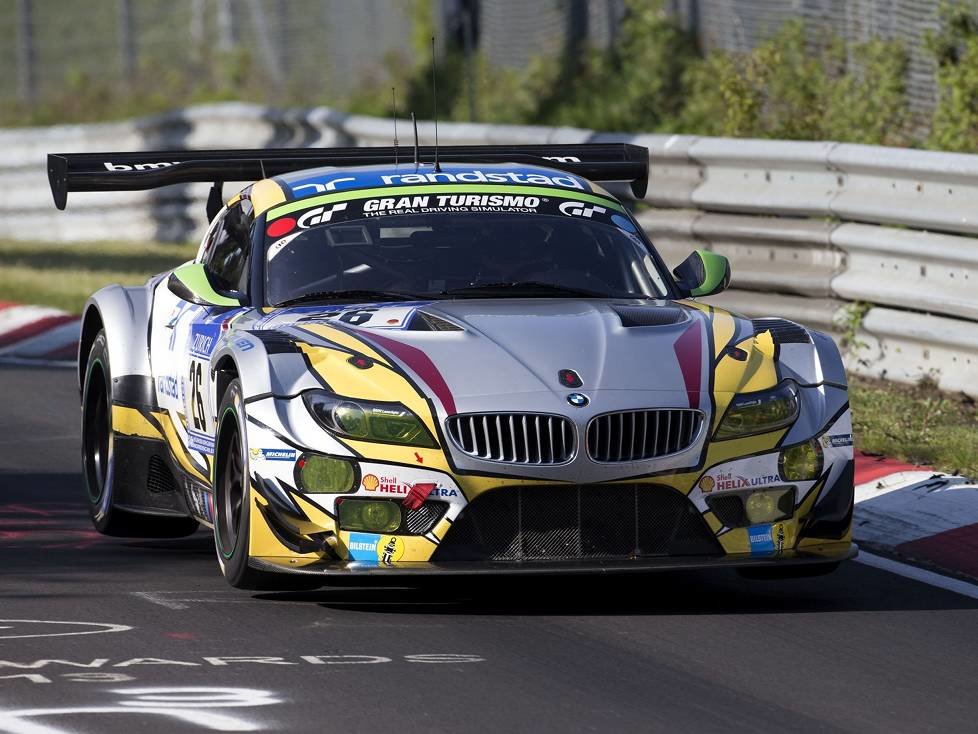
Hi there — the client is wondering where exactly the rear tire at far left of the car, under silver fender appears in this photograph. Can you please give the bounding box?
[81,329,197,538]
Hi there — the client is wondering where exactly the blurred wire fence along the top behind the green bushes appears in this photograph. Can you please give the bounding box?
[0,0,940,131]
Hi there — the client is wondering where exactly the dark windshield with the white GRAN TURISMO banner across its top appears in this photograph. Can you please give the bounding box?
[265,195,668,305]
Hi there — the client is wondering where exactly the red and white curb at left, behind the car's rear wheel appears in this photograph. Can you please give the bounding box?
[0,301,80,365]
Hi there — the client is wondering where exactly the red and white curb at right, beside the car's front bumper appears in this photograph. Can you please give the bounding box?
[853,452,978,579]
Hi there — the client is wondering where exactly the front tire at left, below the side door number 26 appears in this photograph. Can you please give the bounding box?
[214,378,322,591]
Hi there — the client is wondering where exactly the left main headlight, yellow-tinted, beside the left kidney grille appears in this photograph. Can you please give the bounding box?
[302,390,438,448]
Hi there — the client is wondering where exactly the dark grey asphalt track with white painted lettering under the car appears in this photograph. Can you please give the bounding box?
[0,367,978,734]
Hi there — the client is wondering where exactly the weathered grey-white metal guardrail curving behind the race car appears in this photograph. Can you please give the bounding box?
[0,103,978,395]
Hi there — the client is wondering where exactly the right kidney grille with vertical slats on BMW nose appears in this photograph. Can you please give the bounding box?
[587,409,703,463]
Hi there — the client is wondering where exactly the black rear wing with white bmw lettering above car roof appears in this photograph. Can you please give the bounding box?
[48,143,649,209]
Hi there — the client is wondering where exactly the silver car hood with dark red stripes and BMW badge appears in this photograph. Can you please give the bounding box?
[267,299,757,415]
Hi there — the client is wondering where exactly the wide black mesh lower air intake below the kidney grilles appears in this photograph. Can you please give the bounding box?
[432,484,722,562]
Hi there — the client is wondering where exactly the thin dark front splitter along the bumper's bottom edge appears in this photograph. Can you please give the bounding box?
[249,542,859,576]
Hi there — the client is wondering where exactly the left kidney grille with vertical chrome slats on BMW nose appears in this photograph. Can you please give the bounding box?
[446,413,575,464]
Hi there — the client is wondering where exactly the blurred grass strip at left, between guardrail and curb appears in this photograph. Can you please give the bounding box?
[0,240,196,313]
